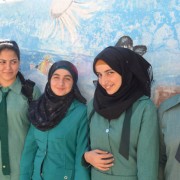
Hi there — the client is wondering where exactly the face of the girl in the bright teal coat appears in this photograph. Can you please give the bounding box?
[50,69,73,96]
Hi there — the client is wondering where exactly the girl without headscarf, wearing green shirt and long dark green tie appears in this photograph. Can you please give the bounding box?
[0,40,40,180]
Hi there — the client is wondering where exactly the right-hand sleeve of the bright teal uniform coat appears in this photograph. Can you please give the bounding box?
[74,108,90,180]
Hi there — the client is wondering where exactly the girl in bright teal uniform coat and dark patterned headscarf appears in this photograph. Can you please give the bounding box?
[20,61,89,180]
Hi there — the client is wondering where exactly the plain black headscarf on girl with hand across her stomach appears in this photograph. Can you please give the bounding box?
[93,46,152,120]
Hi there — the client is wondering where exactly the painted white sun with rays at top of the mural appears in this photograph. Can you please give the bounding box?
[50,0,99,41]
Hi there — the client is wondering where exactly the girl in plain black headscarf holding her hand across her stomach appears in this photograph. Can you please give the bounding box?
[84,47,159,180]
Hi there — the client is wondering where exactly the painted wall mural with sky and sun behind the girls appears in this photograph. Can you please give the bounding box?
[0,0,180,105]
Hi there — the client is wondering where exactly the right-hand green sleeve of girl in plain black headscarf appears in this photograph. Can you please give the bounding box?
[137,101,159,180]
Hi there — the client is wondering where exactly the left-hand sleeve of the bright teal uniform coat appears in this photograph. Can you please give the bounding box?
[20,125,38,180]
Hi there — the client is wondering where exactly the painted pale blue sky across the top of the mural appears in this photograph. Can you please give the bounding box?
[0,0,180,55]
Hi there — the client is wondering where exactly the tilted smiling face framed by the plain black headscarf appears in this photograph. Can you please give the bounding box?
[95,60,122,95]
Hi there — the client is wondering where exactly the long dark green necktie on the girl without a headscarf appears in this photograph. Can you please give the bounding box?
[0,91,10,175]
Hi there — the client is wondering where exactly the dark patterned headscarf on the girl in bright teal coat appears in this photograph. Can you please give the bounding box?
[29,61,86,131]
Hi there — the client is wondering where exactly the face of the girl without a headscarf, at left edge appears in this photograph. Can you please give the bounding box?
[0,49,20,87]
